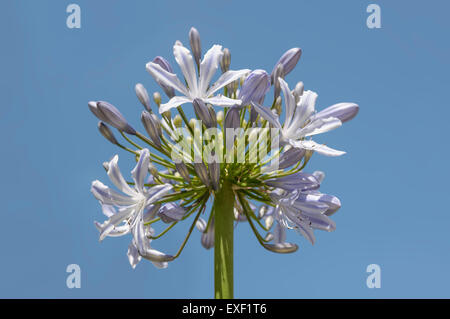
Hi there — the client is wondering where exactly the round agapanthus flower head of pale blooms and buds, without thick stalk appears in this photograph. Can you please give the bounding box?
[88,28,359,268]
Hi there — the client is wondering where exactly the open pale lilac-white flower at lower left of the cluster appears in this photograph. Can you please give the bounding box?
[91,149,172,268]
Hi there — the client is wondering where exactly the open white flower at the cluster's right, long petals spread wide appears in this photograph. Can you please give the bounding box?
[252,78,345,156]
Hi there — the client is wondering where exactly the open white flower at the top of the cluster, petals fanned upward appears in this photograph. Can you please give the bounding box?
[146,44,250,113]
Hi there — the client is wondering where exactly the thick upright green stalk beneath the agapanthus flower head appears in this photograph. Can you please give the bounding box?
[214,181,235,299]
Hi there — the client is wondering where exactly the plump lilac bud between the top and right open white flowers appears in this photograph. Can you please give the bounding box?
[239,70,270,106]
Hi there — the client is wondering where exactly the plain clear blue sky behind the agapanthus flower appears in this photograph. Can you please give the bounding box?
[0,0,450,298]
